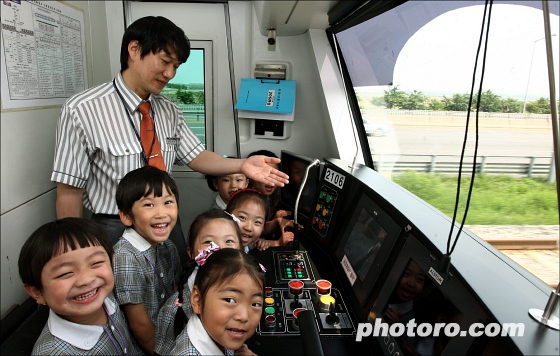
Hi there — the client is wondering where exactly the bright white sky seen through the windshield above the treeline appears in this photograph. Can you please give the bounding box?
[356,4,560,100]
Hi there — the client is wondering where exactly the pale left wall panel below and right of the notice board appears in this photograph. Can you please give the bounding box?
[0,1,115,313]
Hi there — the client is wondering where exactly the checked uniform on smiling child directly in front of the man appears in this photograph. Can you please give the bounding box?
[113,228,181,324]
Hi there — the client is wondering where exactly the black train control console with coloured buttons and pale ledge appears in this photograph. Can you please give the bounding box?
[247,156,558,356]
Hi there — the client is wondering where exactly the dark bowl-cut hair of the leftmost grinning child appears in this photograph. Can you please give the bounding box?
[18,218,113,291]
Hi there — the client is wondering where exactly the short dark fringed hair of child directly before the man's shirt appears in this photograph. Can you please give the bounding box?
[116,166,179,216]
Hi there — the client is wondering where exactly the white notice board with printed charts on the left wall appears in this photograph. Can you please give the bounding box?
[0,0,88,109]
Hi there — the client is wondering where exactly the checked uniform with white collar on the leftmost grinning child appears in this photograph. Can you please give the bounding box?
[31,293,144,355]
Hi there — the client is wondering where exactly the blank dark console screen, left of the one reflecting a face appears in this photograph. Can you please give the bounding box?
[344,208,387,281]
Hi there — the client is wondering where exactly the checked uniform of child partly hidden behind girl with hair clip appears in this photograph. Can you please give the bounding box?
[154,270,196,355]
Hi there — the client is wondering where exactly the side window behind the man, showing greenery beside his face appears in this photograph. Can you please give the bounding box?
[161,41,214,170]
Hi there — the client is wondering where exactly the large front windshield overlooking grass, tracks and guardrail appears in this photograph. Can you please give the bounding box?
[336,1,560,286]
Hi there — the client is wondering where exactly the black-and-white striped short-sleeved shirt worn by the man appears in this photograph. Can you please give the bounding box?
[51,74,204,214]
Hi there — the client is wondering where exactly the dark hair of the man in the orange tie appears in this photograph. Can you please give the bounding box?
[121,16,191,71]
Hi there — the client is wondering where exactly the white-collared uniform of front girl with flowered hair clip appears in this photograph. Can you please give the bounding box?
[171,314,235,356]
